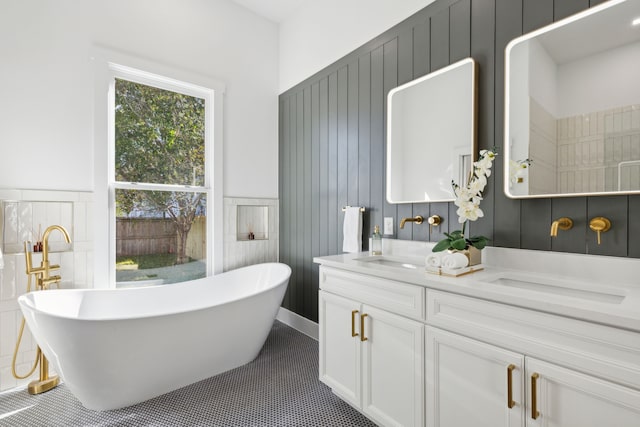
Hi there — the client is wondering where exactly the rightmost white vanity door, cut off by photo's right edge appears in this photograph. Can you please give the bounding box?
[526,358,640,427]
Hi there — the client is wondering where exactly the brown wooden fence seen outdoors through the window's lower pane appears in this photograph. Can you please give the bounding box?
[116,217,206,259]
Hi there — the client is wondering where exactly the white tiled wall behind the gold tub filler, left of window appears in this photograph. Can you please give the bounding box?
[0,190,93,391]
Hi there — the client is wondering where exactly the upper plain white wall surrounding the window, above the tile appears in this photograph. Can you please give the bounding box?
[0,0,278,197]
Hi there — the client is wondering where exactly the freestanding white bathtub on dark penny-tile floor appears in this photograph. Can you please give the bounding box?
[18,263,291,411]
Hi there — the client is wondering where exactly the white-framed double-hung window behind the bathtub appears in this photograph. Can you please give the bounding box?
[109,66,213,287]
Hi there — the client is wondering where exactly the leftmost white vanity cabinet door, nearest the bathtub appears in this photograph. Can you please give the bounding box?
[318,291,362,408]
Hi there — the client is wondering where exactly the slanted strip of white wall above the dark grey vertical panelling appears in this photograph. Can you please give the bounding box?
[280,0,434,93]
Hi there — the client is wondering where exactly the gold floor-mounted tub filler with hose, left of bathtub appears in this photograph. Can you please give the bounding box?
[11,225,71,394]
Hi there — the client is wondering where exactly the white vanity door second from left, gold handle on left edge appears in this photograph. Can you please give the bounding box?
[362,305,424,427]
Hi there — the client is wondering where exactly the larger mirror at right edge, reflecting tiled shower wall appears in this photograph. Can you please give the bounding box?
[504,0,640,198]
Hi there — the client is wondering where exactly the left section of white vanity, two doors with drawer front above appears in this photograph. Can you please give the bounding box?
[319,267,424,426]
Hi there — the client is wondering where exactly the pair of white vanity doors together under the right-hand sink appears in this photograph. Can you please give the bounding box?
[426,327,640,427]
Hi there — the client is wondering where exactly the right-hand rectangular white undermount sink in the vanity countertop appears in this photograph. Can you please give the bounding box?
[482,272,626,304]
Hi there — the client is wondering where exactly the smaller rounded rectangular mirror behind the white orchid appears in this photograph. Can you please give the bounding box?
[387,58,477,203]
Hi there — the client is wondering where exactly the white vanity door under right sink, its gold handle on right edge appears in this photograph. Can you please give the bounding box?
[425,326,524,427]
